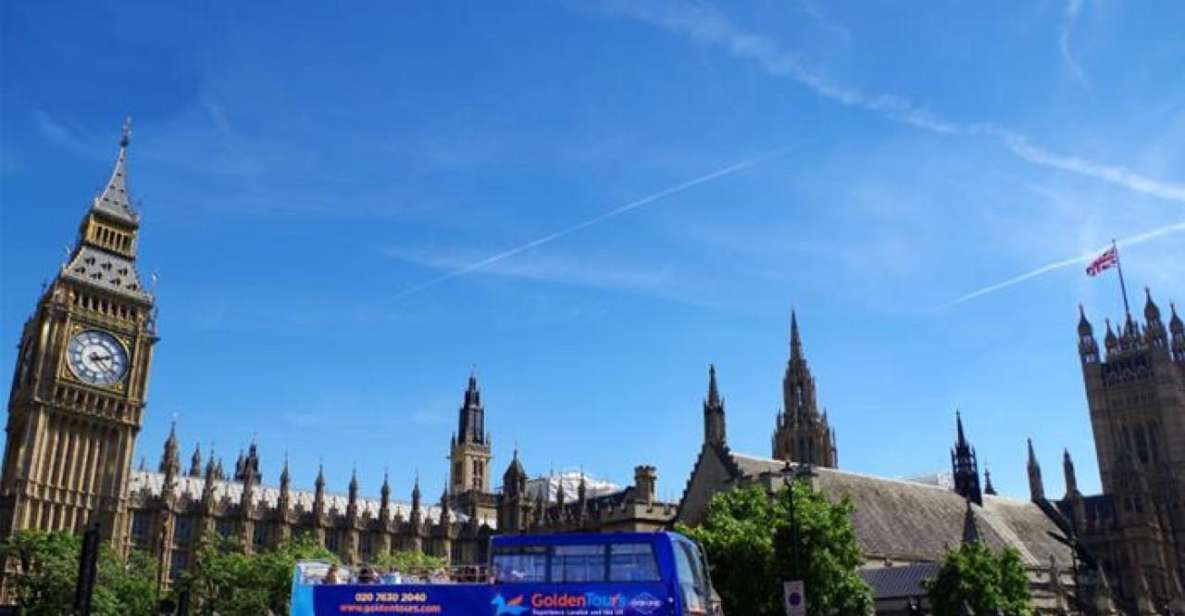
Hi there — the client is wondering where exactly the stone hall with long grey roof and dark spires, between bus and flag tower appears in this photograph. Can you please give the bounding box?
[677,315,1115,614]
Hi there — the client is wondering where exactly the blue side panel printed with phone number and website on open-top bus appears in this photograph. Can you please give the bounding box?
[310,584,495,616]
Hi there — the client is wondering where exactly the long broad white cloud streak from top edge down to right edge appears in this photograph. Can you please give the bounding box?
[610,1,1185,203]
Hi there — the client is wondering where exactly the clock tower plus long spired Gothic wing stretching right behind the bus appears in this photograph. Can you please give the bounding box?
[0,127,674,592]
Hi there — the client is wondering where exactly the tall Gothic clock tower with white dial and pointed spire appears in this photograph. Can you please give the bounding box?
[0,123,156,551]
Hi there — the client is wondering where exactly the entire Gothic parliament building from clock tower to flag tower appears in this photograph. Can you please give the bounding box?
[0,128,1185,615]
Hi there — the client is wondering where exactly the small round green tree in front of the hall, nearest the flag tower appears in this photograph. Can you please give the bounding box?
[925,541,1032,616]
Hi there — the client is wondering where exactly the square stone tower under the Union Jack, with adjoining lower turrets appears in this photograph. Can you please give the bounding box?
[1029,296,1185,614]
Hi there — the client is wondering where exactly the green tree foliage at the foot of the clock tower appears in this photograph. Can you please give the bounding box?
[0,531,156,616]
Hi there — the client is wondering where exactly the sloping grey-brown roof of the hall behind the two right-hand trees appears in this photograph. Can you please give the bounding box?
[730,453,1071,566]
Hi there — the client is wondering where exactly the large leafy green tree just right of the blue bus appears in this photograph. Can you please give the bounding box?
[679,482,872,616]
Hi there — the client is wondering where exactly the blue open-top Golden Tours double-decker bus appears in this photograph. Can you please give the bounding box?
[292,532,722,616]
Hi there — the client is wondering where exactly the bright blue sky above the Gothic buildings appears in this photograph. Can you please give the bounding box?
[0,0,1185,499]
